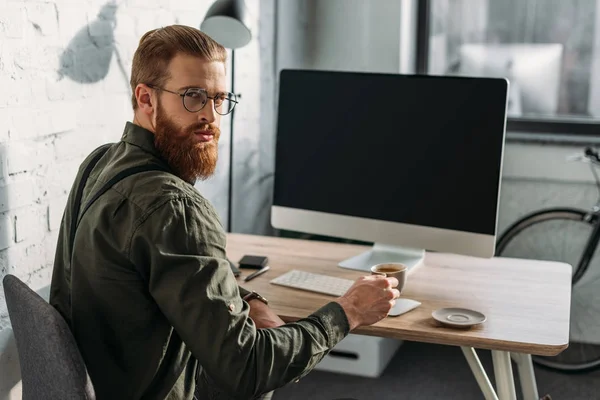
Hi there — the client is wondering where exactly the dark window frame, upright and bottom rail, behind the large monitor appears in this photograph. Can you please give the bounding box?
[415,0,600,143]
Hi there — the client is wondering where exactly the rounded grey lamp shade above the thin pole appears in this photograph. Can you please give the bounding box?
[200,0,252,49]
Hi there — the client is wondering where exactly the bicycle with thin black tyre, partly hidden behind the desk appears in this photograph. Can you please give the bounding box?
[496,147,600,372]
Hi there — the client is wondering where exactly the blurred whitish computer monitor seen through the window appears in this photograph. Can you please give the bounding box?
[459,43,563,117]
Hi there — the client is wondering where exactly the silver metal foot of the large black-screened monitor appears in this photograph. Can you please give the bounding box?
[338,243,425,272]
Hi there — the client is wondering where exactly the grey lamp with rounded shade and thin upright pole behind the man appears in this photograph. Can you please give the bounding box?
[200,0,252,276]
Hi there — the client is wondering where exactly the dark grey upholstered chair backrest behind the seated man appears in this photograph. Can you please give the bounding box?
[3,275,96,400]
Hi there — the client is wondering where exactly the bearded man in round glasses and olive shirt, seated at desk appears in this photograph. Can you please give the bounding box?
[50,25,399,400]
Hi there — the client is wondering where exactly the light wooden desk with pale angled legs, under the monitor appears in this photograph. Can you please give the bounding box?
[227,234,571,400]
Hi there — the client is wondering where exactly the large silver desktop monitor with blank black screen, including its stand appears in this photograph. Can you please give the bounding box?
[271,70,508,271]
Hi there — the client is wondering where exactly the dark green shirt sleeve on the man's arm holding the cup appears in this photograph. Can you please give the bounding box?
[129,198,349,399]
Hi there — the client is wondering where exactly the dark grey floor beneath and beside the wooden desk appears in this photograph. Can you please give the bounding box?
[273,342,600,400]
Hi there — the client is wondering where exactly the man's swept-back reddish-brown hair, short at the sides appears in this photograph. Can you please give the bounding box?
[129,25,227,110]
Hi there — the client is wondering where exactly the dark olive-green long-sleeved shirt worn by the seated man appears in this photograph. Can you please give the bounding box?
[50,122,349,400]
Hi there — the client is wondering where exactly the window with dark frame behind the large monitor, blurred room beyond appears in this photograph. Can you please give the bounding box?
[417,0,600,135]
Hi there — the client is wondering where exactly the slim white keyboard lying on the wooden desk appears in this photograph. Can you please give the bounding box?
[270,269,354,297]
